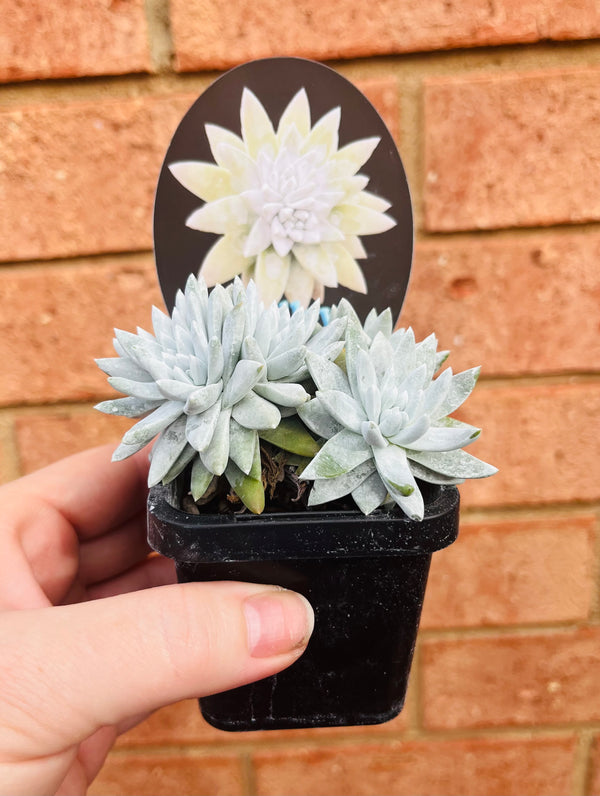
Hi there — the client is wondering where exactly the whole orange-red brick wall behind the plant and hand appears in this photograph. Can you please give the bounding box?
[0,0,600,796]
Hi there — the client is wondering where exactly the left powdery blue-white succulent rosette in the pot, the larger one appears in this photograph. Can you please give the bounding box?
[96,276,346,508]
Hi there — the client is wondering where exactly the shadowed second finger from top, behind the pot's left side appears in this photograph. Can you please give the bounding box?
[78,512,150,584]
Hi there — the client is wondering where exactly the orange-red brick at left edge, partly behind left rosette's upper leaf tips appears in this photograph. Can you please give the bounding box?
[0,256,162,405]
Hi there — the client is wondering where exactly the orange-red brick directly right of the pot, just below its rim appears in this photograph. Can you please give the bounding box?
[421,516,596,628]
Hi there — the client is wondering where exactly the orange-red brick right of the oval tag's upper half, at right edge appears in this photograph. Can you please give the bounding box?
[424,69,600,231]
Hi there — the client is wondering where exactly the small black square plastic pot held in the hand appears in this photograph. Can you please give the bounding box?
[148,486,459,730]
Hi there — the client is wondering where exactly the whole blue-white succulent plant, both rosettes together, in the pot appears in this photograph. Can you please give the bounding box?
[96,276,496,519]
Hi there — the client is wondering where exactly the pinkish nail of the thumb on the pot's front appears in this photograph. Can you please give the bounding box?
[244,589,315,658]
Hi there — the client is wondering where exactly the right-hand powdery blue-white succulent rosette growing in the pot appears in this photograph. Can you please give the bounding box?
[298,318,496,520]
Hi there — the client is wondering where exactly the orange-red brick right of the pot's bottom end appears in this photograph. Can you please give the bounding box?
[421,627,600,729]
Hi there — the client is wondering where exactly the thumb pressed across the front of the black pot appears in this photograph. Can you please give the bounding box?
[0,582,314,759]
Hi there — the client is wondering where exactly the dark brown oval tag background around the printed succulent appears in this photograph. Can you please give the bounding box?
[154,58,413,318]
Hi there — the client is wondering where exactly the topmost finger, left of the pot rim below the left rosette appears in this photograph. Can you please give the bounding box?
[2,445,148,538]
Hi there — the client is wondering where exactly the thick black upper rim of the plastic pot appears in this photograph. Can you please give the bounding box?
[148,486,460,564]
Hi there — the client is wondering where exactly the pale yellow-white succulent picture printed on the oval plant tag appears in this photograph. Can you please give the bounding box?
[169,89,396,307]
